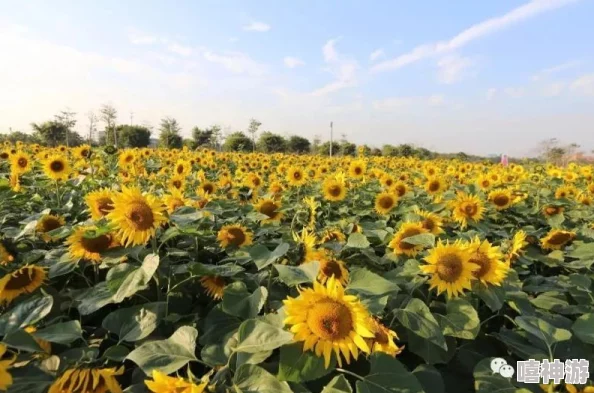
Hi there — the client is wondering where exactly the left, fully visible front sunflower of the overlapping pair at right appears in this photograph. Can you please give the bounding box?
[421,241,479,298]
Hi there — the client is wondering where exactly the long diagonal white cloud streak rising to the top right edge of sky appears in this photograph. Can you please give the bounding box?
[371,0,579,72]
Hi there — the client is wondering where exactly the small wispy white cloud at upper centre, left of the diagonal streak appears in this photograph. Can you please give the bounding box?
[311,39,359,96]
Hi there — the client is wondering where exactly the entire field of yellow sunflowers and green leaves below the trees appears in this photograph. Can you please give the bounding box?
[0,144,594,393]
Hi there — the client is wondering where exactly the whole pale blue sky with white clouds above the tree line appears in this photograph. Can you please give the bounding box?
[0,0,594,156]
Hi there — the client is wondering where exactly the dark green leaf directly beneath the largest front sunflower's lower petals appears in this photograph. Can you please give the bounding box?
[278,343,336,382]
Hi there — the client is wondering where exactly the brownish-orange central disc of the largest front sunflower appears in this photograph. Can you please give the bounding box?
[307,299,353,341]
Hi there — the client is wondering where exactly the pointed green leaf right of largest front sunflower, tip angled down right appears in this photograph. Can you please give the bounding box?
[394,298,447,350]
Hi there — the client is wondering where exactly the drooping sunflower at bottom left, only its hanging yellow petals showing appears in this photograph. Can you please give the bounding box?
[48,367,124,393]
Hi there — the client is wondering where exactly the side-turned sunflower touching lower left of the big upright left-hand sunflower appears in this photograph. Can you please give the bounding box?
[66,226,117,262]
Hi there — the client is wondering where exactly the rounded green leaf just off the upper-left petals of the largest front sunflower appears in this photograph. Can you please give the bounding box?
[222,281,268,319]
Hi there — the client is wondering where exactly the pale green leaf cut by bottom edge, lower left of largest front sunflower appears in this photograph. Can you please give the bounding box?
[233,364,293,393]
